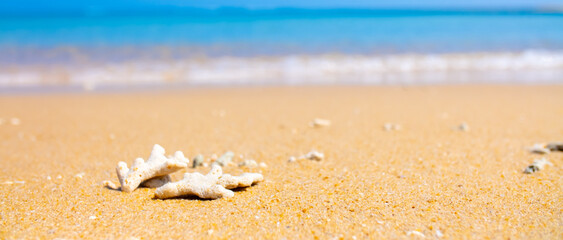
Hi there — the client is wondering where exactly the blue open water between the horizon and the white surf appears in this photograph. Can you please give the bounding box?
[0,10,563,56]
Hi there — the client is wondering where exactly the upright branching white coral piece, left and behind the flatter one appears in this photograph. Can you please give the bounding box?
[116,144,189,192]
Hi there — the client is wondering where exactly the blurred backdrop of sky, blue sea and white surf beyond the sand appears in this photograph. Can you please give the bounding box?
[0,0,563,92]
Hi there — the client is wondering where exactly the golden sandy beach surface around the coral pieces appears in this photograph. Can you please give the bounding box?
[0,86,563,239]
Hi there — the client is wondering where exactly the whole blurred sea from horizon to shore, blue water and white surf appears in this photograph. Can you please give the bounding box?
[0,9,563,86]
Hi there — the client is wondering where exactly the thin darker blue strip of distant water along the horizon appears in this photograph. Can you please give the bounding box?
[0,5,563,17]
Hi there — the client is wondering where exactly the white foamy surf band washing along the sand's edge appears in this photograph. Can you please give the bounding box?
[0,50,563,89]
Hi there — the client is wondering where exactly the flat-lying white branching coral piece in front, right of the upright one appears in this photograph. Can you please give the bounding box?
[155,164,234,199]
